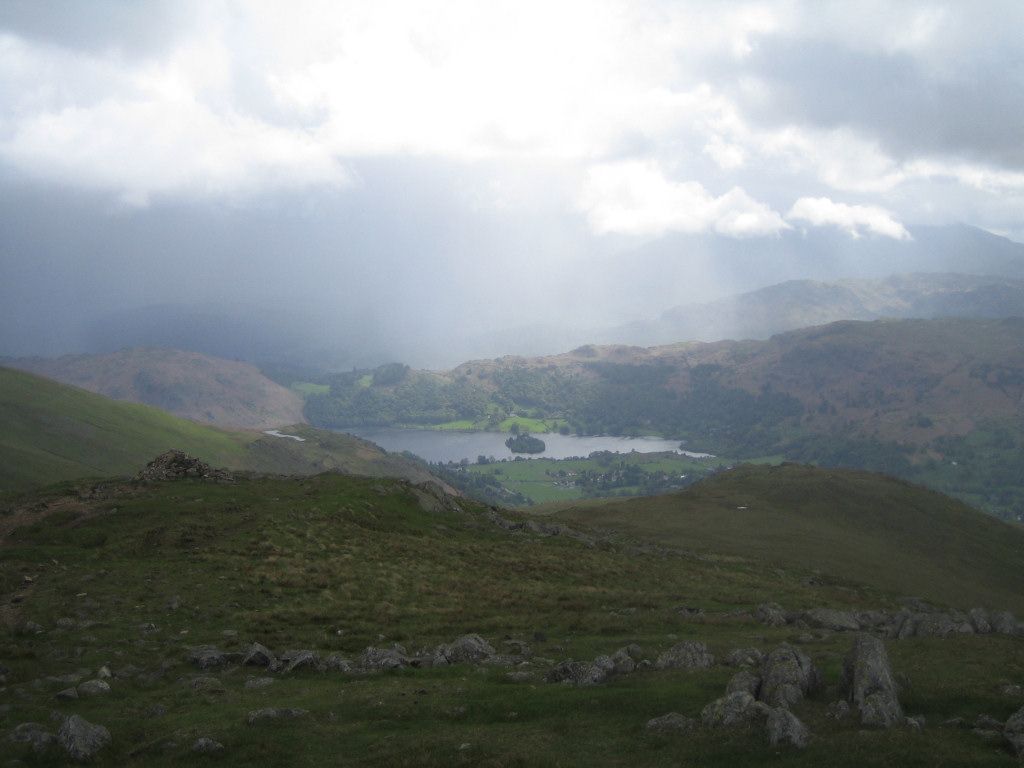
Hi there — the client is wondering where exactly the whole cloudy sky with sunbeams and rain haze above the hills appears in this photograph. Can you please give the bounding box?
[0,0,1024,365]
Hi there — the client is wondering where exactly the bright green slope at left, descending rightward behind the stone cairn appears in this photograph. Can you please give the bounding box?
[0,368,438,497]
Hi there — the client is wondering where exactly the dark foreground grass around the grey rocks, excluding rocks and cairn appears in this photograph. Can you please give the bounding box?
[0,468,1024,768]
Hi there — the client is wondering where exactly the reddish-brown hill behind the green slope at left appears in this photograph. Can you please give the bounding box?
[8,348,304,429]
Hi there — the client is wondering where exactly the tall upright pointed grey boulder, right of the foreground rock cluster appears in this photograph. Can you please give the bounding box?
[843,634,903,728]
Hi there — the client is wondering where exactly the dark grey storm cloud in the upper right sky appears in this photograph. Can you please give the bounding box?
[743,33,1024,168]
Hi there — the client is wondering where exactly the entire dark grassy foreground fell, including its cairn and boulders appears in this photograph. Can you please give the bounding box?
[0,455,1024,766]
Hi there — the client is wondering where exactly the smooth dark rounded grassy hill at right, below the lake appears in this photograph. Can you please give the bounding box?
[555,464,1024,612]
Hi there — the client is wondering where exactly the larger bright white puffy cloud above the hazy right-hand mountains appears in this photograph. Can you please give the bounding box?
[580,161,790,238]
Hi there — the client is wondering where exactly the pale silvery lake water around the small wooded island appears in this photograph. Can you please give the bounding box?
[338,427,711,462]
